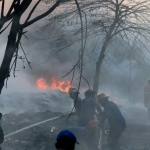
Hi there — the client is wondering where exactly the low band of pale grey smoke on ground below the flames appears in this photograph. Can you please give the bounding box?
[0,91,73,114]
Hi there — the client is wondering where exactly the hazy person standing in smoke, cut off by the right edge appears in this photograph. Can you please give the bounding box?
[144,79,150,121]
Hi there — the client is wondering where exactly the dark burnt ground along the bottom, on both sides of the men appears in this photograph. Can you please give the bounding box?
[2,111,150,150]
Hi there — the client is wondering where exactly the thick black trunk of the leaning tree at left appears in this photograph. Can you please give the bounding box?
[0,0,32,94]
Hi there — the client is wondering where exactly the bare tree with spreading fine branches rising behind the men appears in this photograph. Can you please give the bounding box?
[30,0,150,93]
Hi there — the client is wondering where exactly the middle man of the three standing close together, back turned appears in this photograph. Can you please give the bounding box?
[79,89,96,126]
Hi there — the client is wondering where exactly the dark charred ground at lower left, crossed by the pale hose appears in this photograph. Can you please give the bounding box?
[2,111,69,150]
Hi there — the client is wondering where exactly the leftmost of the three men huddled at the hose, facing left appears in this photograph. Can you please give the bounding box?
[69,87,82,117]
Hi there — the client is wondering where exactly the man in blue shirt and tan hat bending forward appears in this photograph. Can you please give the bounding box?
[97,93,126,150]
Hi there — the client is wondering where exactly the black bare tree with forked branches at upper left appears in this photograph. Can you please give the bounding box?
[0,0,66,93]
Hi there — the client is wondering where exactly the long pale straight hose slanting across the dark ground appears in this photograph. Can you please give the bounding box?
[4,112,70,138]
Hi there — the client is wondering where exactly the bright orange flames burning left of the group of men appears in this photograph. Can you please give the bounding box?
[36,77,71,92]
